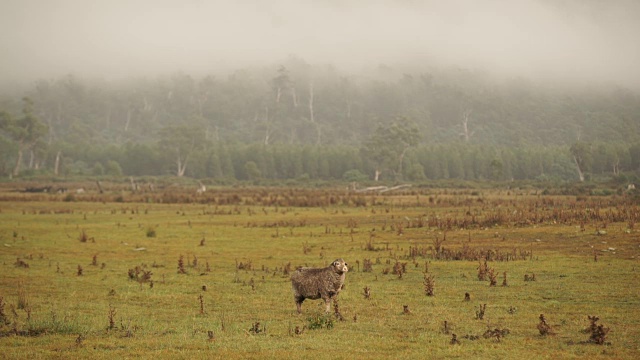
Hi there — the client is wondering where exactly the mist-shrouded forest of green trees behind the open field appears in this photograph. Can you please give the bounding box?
[0,56,640,183]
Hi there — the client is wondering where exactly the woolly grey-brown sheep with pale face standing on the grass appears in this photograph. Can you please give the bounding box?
[291,259,349,314]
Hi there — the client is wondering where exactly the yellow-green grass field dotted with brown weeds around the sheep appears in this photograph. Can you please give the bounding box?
[0,186,640,359]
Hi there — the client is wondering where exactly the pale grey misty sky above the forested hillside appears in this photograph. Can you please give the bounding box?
[0,0,640,88]
